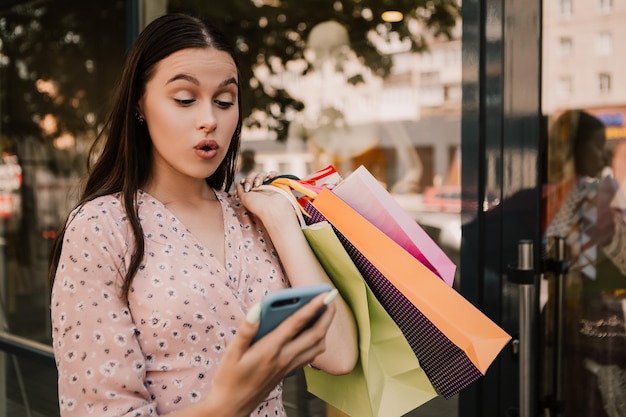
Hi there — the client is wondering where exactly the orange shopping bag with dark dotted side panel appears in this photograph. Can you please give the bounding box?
[307,189,511,398]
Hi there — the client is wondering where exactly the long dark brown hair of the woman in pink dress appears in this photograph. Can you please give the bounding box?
[48,14,241,300]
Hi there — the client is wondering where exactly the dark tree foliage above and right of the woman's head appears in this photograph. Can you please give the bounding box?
[168,0,460,139]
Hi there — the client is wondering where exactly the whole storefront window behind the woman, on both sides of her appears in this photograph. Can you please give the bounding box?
[0,0,462,416]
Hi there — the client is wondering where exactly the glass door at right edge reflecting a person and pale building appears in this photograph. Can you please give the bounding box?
[541,0,626,417]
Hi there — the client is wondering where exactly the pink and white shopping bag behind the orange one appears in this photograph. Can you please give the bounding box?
[333,165,456,286]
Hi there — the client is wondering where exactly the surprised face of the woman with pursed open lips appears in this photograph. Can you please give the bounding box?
[139,48,239,183]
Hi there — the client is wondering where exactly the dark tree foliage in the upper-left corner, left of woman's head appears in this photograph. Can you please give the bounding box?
[0,0,126,172]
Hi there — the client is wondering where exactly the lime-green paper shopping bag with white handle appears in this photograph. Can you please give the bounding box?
[260,181,438,417]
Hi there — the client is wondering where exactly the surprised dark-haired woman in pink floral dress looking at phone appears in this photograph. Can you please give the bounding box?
[50,15,357,417]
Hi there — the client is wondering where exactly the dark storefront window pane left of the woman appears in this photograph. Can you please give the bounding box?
[0,0,127,416]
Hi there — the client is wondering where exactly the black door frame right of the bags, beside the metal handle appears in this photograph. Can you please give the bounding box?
[459,0,544,417]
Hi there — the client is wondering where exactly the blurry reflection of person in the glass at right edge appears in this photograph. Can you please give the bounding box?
[545,111,626,417]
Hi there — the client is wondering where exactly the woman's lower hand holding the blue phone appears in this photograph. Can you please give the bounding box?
[204,293,336,416]
